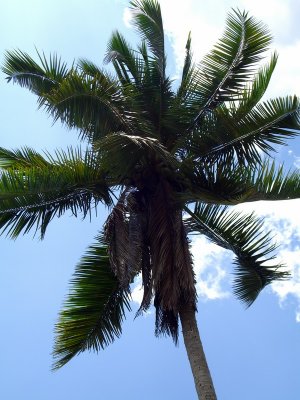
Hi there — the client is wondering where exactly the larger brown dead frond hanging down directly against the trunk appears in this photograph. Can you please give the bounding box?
[147,181,196,342]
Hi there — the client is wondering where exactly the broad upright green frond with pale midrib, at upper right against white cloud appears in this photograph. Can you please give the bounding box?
[193,10,271,126]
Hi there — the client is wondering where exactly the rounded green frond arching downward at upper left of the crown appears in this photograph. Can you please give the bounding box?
[45,72,132,140]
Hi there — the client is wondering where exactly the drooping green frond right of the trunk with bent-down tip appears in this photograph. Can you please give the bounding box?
[185,203,289,306]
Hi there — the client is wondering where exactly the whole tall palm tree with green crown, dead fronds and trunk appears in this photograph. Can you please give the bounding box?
[0,0,300,399]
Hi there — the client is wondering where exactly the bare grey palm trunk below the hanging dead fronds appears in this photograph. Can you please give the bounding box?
[179,305,217,400]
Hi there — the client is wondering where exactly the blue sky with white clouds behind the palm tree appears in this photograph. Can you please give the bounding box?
[0,0,300,400]
